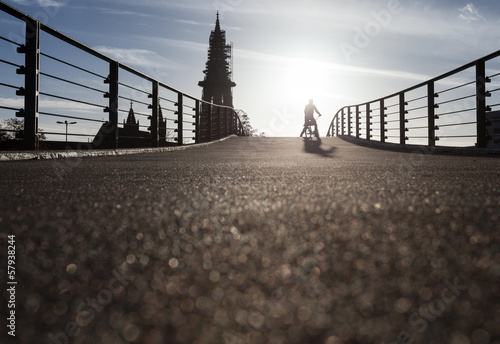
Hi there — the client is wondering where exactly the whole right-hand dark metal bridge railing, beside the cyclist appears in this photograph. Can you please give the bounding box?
[327,50,500,147]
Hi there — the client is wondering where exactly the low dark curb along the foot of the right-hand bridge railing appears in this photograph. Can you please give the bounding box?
[338,135,500,157]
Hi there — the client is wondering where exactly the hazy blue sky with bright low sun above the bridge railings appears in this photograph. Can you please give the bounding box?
[0,0,500,142]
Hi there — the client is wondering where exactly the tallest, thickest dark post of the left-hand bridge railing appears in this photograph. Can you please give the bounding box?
[23,18,40,150]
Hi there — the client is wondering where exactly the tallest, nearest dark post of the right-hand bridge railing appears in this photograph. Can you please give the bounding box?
[476,60,488,148]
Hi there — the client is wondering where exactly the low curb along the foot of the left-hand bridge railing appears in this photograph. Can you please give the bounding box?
[0,135,236,161]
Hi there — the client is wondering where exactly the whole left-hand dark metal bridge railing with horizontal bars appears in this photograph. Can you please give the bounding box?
[0,2,245,150]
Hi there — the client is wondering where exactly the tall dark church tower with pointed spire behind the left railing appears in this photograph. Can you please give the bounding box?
[198,12,236,141]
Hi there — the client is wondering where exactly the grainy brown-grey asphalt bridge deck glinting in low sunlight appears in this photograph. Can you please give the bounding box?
[0,138,500,344]
